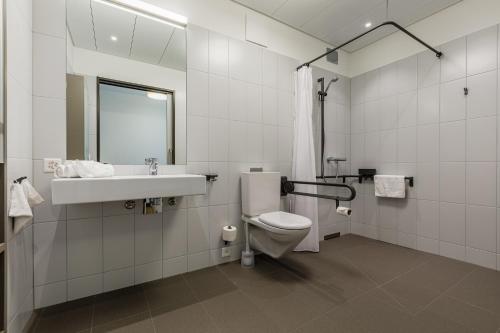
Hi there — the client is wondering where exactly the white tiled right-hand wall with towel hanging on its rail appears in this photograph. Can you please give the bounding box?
[351,26,500,269]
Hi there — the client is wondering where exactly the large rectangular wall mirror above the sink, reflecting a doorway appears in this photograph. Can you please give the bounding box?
[66,0,186,165]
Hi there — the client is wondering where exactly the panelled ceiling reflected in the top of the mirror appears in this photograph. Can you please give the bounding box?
[67,0,186,71]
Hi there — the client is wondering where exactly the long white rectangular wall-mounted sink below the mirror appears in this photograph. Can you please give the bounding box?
[52,174,207,205]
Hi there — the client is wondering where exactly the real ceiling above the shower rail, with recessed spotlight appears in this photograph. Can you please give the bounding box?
[232,0,461,52]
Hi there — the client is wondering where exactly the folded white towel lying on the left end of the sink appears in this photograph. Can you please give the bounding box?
[55,161,115,178]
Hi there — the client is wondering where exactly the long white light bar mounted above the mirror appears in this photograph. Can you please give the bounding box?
[93,0,187,29]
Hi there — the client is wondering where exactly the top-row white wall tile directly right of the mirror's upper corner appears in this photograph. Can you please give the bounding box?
[187,25,208,72]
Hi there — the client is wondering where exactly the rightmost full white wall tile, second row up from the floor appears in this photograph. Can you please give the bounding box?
[467,206,497,252]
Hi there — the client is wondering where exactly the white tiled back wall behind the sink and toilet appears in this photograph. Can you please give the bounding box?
[33,20,349,308]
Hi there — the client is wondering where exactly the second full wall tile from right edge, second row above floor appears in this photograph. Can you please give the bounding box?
[439,202,466,245]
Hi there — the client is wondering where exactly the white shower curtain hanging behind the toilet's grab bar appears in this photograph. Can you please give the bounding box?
[292,66,319,252]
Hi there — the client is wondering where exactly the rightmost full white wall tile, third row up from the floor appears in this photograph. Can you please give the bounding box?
[467,163,497,206]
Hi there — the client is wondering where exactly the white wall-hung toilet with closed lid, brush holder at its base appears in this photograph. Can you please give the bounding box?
[241,172,312,266]
